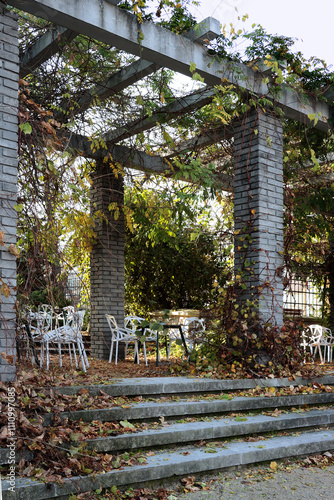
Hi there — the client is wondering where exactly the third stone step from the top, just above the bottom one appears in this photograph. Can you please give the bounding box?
[79,409,334,453]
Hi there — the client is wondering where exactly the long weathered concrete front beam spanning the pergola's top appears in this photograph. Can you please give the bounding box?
[10,0,330,131]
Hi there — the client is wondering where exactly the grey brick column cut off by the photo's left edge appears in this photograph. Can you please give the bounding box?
[0,3,19,381]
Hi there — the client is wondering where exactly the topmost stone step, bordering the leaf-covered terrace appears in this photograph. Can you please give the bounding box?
[55,372,334,397]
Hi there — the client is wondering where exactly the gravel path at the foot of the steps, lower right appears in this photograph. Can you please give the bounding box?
[177,465,334,500]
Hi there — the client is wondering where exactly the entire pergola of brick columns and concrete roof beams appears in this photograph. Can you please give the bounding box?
[0,0,332,380]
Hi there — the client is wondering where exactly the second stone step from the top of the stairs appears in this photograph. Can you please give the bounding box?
[44,392,334,425]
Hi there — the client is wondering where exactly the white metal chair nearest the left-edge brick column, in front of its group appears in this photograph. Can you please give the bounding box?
[43,311,89,372]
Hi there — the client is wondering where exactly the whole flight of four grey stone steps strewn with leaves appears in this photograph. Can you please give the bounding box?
[2,376,334,500]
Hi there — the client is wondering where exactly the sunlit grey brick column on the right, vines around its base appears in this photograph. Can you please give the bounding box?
[234,111,283,326]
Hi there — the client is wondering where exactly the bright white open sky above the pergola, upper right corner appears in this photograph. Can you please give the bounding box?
[191,0,334,71]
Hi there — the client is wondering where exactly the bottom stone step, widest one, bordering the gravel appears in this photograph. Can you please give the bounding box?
[2,430,334,500]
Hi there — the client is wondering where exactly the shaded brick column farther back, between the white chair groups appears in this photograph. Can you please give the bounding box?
[90,161,124,359]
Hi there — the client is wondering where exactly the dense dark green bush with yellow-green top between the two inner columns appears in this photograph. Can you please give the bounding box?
[125,186,229,311]
